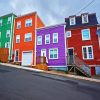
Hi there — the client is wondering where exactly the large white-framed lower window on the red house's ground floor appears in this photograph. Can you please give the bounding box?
[82,46,93,59]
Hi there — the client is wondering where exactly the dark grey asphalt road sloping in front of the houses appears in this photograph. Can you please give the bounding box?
[0,65,100,100]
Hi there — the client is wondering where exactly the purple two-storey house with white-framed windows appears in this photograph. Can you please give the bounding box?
[36,24,67,70]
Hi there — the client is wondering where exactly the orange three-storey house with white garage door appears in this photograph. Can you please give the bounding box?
[13,12,44,66]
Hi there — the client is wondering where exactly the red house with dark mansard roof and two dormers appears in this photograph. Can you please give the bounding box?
[65,13,100,75]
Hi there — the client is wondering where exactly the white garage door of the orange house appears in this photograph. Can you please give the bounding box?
[22,52,32,66]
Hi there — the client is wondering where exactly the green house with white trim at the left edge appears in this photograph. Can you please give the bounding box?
[0,13,16,60]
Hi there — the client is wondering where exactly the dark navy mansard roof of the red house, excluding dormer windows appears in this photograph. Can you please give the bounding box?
[65,13,98,29]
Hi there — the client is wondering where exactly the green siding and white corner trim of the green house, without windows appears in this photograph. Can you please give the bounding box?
[0,14,16,60]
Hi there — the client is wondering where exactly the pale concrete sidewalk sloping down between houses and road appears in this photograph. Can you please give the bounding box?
[0,63,100,83]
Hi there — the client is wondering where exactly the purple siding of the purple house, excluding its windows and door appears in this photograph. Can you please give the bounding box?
[36,25,66,66]
